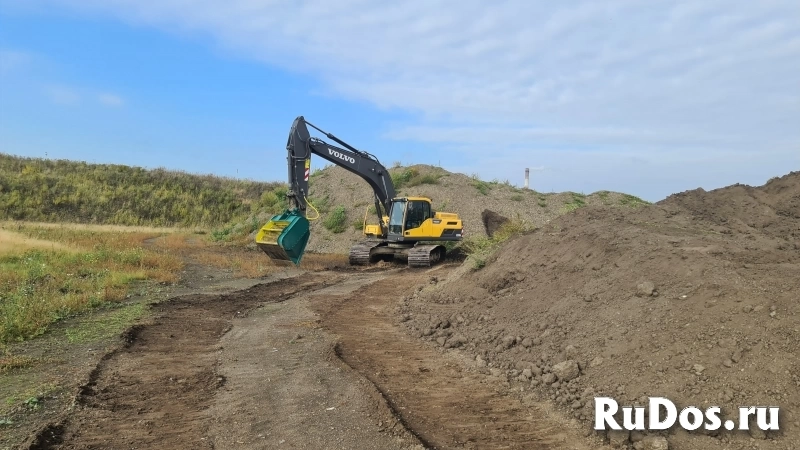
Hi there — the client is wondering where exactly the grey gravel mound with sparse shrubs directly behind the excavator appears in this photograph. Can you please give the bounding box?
[294,163,641,253]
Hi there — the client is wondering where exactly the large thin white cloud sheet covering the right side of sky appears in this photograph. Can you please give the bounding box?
[21,0,800,197]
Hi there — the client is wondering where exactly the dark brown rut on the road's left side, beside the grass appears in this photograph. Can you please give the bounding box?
[27,275,331,449]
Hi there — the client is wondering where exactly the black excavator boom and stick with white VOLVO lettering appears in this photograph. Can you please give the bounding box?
[286,116,395,225]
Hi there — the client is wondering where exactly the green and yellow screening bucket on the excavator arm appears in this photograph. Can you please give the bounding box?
[256,211,311,265]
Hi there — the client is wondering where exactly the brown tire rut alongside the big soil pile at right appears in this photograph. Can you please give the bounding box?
[312,269,590,450]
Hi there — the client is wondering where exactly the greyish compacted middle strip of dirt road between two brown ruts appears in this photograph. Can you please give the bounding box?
[203,273,424,450]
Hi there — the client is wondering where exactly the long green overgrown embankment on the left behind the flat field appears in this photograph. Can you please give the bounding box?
[0,153,285,228]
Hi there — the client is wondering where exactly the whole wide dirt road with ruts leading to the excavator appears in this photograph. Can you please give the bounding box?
[21,266,604,449]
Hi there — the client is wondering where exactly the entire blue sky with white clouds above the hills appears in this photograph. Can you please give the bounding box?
[0,0,800,201]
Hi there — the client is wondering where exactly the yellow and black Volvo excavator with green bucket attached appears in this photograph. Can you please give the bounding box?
[255,116,464,267]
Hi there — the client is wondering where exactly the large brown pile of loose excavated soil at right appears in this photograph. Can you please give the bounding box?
[398,172,800,449]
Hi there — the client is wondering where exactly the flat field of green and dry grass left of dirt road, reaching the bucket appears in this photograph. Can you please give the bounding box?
[0,218,347,344]
